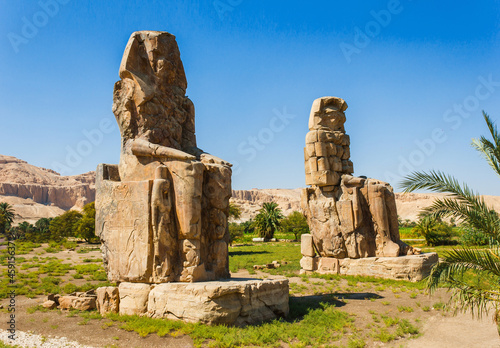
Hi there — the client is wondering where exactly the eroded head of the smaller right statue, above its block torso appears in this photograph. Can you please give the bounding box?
[309,97,347,132]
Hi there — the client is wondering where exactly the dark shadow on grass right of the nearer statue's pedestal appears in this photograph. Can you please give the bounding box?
[288,292,383,321]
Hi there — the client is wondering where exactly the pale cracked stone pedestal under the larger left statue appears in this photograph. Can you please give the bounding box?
[97,279,289,326]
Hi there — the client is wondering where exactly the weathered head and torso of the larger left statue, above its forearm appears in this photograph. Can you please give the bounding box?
[113,31,196,150]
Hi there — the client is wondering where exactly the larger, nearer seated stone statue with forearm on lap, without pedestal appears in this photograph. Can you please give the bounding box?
[96,31,231,283]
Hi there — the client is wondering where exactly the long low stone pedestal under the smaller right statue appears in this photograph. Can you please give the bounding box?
[300,253,438,282]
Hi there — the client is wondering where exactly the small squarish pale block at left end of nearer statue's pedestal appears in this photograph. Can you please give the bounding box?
[118,282,151,315]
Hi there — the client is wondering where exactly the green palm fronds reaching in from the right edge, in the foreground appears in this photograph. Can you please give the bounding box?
[402,112,500,326]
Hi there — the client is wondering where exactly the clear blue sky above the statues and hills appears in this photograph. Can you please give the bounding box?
[0,0,500,195]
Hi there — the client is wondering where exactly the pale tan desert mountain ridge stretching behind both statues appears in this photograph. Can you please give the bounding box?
[0,155,500,223]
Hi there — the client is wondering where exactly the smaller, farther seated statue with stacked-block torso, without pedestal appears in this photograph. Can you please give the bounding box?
[301,97,413,259]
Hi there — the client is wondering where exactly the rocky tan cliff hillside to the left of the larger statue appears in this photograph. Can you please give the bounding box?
[0,155,95,222]
